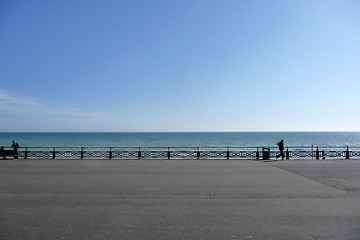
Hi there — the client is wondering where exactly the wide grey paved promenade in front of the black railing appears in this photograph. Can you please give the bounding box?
[0,160,360,240]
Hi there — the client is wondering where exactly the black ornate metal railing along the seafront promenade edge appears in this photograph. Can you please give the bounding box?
[0,146,360,160]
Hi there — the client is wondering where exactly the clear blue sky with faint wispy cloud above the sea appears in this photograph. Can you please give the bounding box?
[0,0,360,132]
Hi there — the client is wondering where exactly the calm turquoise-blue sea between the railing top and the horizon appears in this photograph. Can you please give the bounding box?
[0,132,360,147]
